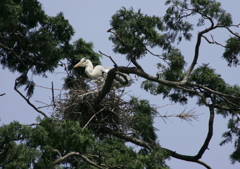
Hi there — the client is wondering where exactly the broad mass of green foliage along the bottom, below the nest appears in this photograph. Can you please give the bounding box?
[0,117,169,169]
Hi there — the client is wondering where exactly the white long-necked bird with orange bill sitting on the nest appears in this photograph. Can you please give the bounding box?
[74,58,133,88]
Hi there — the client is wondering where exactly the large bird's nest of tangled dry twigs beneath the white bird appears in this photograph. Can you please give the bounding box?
[52,81,133,135]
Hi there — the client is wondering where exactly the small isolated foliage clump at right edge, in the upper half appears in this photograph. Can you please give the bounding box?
[223,37,240,66]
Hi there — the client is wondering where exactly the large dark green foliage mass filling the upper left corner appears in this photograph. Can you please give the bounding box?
[0,0,74,97]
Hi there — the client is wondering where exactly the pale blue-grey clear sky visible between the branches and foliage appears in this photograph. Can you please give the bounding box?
[0,0,240,169]
